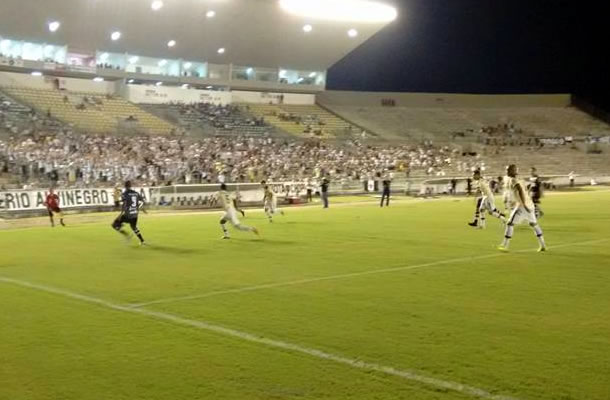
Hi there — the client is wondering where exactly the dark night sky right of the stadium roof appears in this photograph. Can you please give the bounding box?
[328,0,610,106]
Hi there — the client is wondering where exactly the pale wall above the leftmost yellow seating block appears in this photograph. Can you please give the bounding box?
[0,72,116,94]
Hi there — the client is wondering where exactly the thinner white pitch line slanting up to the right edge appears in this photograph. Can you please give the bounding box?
[128,238,610,308]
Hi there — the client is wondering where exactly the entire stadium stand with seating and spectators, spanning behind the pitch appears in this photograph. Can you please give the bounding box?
[0,86,610,191]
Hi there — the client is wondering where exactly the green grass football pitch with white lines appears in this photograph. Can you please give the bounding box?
[0,191,610,400]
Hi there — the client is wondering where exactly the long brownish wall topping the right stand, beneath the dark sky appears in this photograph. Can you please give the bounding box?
[316,90,571,108]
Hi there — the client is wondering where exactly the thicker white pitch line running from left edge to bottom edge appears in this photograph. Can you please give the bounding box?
[0,277,518,400]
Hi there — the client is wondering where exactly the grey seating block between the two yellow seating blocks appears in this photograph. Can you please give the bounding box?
[141,103,274,136]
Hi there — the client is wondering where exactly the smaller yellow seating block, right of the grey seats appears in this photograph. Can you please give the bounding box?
[243,104,361,137]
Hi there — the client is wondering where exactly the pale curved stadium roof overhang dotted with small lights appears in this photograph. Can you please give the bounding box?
[0,0,393,70]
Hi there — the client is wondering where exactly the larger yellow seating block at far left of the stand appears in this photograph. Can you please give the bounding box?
[3,87,175,134]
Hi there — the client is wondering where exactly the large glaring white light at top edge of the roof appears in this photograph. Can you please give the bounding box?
[280,0,398,23]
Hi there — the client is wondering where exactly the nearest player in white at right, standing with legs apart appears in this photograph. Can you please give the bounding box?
[498,164,546,251]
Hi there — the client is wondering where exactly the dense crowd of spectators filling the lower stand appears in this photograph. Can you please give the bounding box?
[0,132,466,186]
